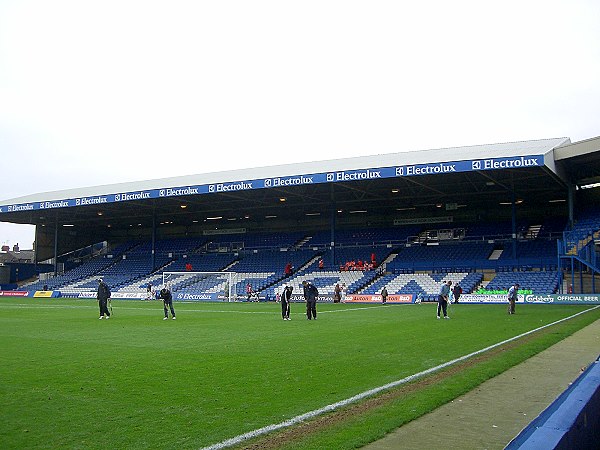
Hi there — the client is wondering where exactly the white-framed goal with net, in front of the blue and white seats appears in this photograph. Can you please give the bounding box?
[162,272,235,302]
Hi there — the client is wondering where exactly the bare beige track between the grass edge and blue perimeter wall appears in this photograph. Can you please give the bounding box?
[363,320,600,450]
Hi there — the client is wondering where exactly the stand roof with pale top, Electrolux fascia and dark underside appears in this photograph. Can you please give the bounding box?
[0,137,600,278]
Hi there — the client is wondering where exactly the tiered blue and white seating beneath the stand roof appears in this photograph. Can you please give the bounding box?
[17,215,576,301]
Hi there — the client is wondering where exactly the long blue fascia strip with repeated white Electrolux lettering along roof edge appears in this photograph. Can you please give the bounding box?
[0,155,544,213]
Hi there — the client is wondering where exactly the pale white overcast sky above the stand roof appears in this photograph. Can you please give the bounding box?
[0,0,600,249]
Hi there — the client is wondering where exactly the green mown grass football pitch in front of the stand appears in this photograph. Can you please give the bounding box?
[0,298,600,449]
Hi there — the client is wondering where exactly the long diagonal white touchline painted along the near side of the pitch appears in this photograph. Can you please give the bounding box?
[201,305,600,450]
